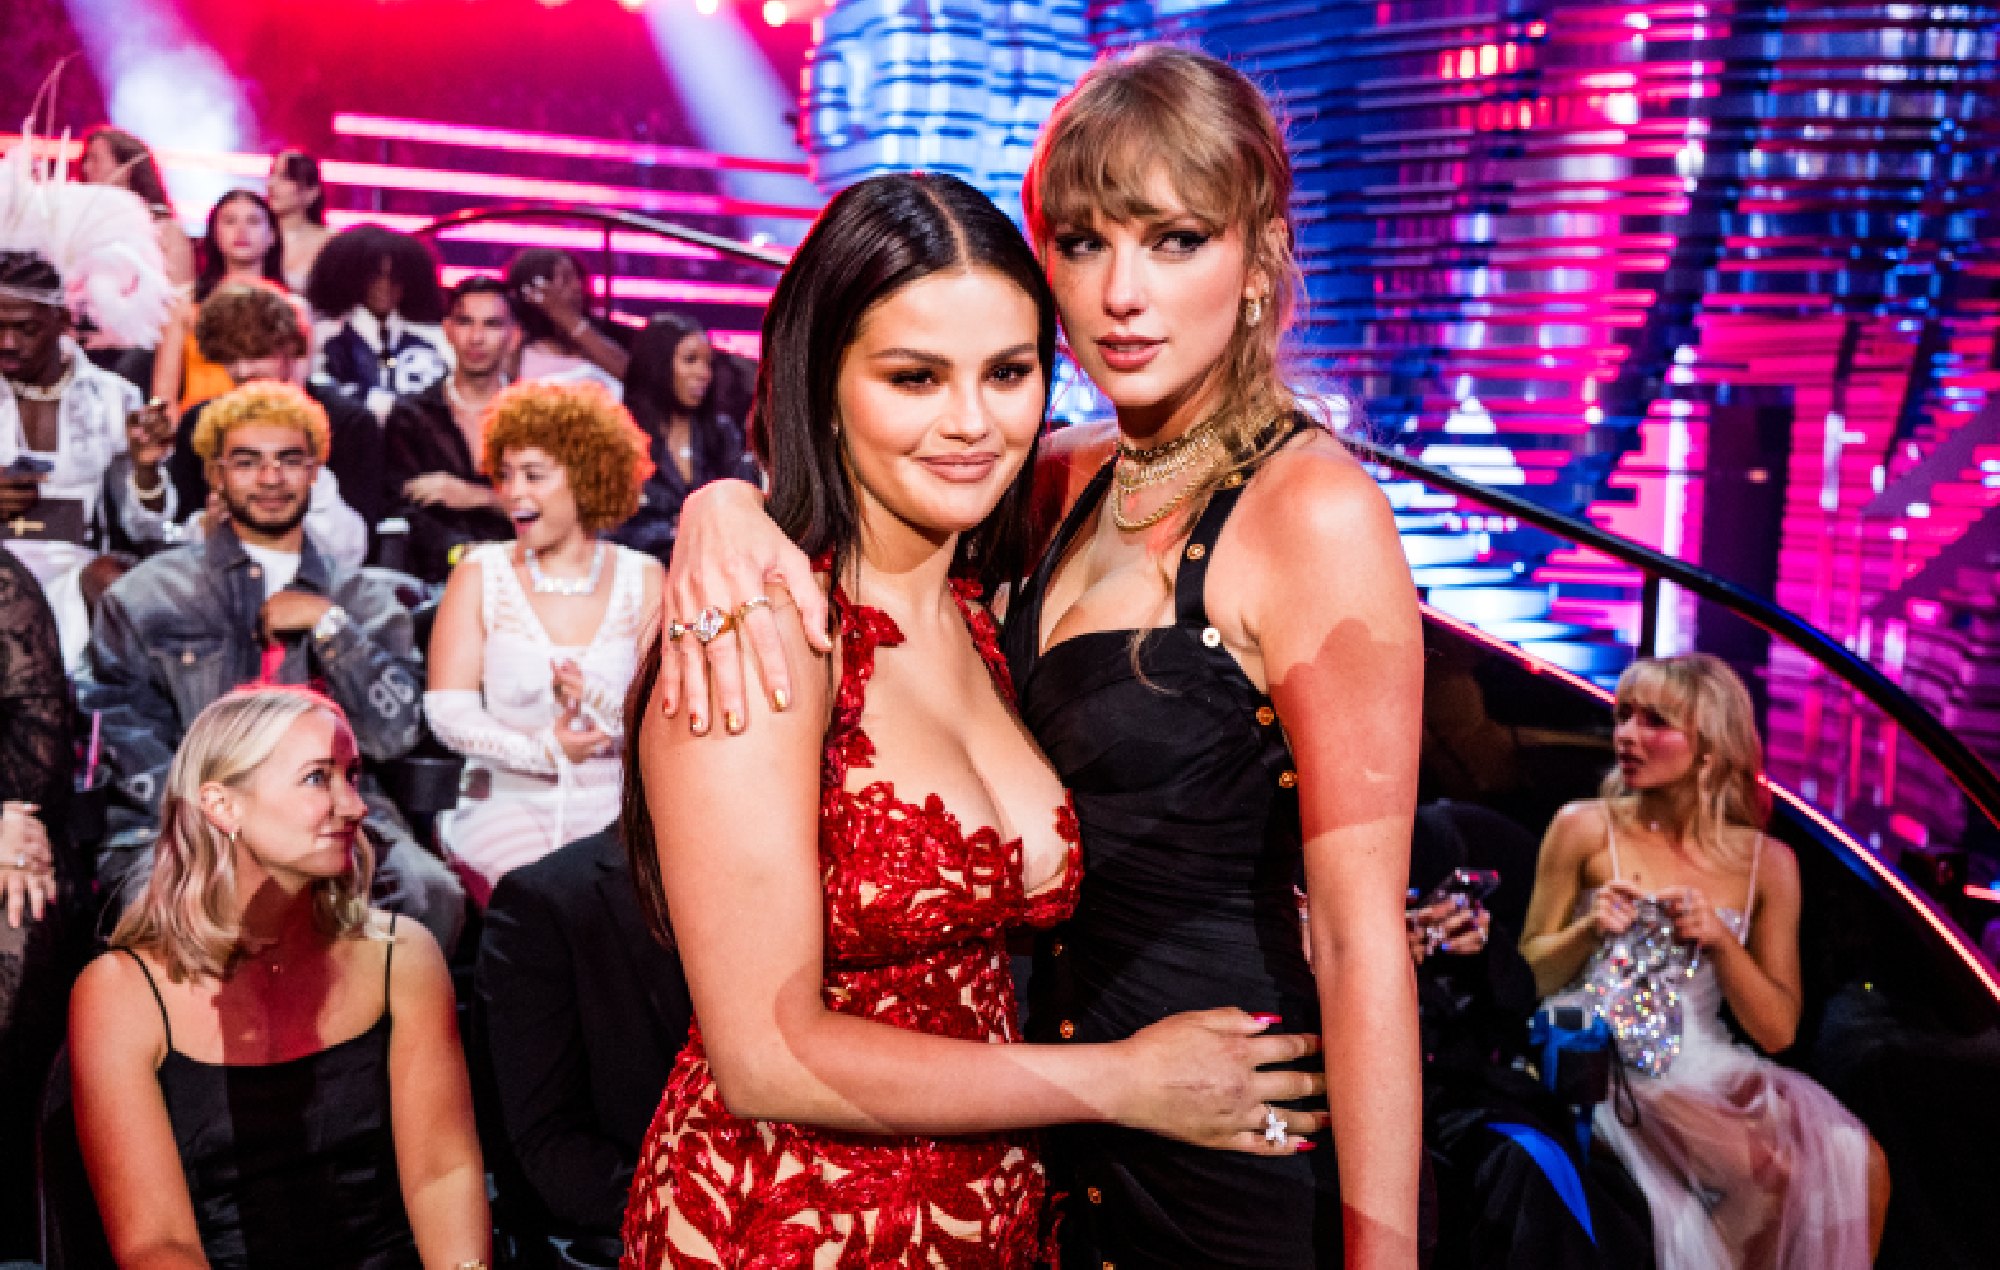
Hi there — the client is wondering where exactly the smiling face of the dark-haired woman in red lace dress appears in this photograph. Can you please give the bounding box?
[836,268,1044,540]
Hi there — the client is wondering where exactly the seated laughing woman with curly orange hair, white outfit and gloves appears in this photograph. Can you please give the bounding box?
[424,384,660,902]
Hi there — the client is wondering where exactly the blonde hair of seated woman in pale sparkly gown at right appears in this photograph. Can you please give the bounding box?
[1598,652,1770,868]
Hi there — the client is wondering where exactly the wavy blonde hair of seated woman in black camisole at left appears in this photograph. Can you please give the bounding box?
[110,686,374,982]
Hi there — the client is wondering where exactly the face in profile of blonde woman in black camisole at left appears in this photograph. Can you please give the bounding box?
[219,710,368,890]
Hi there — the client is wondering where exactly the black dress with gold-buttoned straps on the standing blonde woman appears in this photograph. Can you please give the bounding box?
[1004,440,1342,1270]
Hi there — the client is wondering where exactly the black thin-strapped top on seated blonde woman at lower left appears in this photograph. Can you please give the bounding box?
[122,926,422,1270]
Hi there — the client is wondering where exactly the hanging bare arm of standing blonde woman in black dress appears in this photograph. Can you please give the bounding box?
[1242,448,1424,1268]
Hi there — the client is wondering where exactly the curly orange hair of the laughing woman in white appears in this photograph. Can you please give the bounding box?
[480,382,652,534]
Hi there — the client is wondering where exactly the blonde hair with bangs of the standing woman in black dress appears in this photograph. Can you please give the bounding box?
[1020,44,1304,516]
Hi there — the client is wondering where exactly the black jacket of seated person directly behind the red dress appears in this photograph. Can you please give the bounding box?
[476,826,692,1234]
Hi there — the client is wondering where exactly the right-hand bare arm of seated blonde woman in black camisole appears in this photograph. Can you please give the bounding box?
[388,922,492,1268]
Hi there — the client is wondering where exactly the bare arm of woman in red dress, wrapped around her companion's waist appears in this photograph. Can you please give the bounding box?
[638,604,1320,1154]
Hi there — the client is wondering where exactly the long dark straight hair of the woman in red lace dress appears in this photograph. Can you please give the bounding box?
[622,172,1056,944]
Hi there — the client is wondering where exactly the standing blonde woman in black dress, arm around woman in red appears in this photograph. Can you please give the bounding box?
[648,48,1422,1268]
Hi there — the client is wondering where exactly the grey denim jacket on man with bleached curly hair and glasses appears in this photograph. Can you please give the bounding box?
[78,526,424,892]
